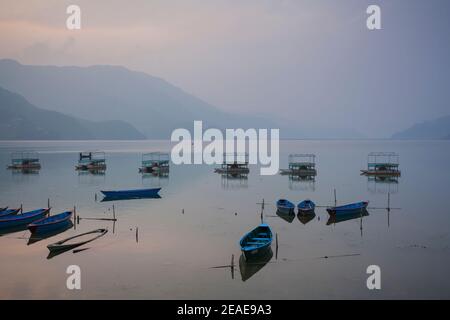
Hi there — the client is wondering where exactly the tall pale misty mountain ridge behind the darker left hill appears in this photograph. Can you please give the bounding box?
[0,59,363,139]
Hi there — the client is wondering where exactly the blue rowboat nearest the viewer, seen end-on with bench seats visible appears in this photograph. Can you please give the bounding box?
[239,223,273,259]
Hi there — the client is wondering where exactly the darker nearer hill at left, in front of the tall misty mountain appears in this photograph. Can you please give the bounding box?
[0,87,145,140]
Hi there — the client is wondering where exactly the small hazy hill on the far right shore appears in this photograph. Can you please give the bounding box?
[392,116,450,140]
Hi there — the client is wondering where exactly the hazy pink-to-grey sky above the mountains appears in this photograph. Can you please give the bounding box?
[0,0,450,137]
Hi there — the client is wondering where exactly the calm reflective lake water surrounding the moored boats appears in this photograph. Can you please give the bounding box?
[0,141,450,299]
